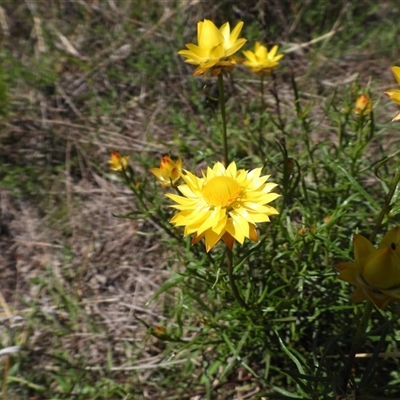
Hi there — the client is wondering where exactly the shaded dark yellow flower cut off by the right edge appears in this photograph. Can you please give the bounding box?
[336,227,400,308]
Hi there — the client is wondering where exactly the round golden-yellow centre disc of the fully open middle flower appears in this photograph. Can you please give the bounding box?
[202,176,240,207]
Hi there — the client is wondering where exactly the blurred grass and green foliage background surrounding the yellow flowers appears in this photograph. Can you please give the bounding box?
[0,0,400,400]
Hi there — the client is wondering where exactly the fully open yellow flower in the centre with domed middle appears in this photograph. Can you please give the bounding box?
[166,162,279,252]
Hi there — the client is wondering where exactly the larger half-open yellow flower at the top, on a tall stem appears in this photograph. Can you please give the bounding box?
[178,19,246,76]
